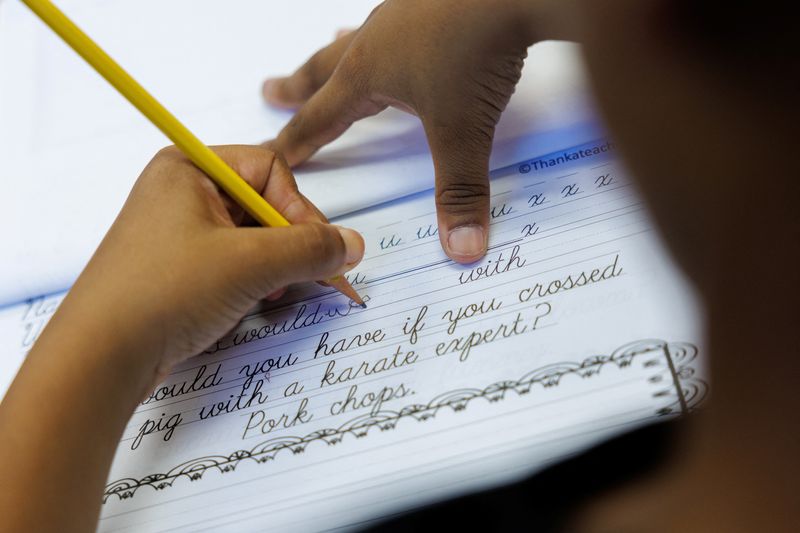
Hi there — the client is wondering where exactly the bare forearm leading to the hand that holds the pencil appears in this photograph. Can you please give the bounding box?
[0,286,159,530]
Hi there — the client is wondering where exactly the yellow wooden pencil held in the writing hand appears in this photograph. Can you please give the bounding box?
[22,0,366,307]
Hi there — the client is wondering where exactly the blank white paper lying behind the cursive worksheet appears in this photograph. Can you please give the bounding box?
[0,0,598,305]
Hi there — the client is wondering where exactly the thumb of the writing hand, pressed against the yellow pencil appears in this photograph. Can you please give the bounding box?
[222,223,364,300]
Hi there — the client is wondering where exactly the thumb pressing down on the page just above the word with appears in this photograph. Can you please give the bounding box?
[423,117,494,263]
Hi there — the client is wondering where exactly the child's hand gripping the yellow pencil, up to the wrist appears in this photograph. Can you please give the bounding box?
[57,146,364,385]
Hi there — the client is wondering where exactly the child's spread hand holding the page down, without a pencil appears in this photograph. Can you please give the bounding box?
[264,0,564,263]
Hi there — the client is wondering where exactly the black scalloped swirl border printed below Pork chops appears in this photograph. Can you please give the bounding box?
[103,339,708,503]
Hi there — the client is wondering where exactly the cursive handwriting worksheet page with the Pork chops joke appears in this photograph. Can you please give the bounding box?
[0,140,706,531]
